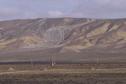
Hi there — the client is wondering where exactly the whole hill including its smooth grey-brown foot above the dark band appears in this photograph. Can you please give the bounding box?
[0,18,126,62]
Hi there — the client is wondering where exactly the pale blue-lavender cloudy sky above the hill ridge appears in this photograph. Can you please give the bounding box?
[0,0,126,20]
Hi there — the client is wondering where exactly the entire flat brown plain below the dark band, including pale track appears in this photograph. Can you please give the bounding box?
[0,64,126,84]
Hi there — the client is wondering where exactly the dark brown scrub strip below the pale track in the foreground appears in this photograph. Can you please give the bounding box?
[0,73,126,84]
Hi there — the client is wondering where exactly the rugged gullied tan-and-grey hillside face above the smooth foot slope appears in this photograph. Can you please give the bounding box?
[0,18,126,52]
